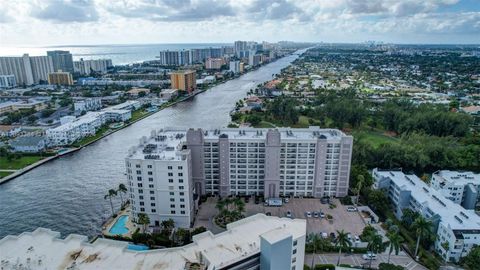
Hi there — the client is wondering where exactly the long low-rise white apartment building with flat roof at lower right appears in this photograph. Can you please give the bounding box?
[373,169,480,262]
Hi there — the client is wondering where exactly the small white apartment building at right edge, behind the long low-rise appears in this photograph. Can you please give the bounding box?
[430,170,480,209]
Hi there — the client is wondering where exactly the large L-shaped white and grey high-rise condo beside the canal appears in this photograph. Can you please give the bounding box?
[126,127,353,227]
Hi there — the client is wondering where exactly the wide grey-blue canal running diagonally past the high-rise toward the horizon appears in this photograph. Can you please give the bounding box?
[0,49,299,239]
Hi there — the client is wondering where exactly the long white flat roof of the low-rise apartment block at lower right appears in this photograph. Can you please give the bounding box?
[374,169,480,230]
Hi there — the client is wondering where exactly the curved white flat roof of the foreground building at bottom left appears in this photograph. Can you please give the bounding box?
[0,214,306,270]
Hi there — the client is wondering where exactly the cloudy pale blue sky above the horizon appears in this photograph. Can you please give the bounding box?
[0,0,480,47]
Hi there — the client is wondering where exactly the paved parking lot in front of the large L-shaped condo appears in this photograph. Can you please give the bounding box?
[195,198,365,237]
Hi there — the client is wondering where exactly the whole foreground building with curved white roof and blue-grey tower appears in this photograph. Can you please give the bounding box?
[0,214,306,270]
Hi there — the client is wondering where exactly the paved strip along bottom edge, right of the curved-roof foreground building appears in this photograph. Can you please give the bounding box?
[305,252,427,270]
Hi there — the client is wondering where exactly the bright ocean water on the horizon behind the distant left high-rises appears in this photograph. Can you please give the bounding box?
[0,43,232,65]
